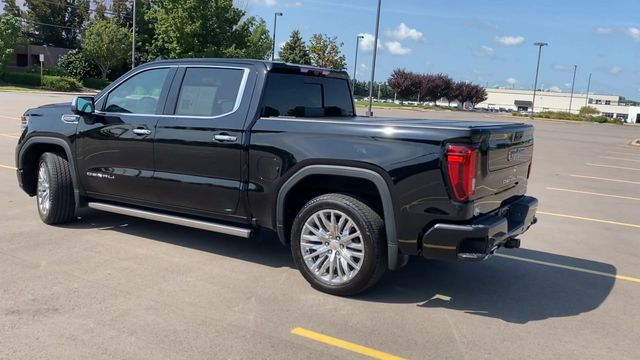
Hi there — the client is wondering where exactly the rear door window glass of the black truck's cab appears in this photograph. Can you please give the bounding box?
[175,68,244,116]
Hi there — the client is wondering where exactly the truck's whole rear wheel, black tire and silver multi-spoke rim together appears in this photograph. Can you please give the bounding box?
[291,194,386,296]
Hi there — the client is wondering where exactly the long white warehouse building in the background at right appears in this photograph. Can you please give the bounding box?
[476,88,640,123]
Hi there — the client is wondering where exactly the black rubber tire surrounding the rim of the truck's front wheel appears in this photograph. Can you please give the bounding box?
[36,153,76,225]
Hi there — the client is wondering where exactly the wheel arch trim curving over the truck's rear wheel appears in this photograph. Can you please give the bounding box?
[276,165,398,270]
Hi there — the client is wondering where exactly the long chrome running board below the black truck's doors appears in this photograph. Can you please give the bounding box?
[87,202,251,238]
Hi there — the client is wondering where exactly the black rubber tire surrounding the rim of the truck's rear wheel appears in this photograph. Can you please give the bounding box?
[291,194,387,296]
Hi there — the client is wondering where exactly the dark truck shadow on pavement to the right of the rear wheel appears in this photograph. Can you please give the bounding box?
[359,249,617,324]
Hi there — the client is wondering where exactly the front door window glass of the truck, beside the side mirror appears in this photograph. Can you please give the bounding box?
[104,68,170,114]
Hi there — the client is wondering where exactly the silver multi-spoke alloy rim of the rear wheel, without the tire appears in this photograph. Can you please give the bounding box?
[300,210,365,285]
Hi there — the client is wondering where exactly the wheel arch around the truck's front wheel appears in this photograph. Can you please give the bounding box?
[16,136,80,207]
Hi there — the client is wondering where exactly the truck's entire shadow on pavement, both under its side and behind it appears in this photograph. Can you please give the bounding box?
[65,211,617,324]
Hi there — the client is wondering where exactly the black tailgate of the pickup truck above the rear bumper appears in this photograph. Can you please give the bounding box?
[473,124,533,200]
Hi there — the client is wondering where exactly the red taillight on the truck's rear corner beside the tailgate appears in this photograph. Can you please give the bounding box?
[445,145,478,201]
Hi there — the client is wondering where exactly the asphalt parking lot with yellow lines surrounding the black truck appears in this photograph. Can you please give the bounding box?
[0,93,640,359]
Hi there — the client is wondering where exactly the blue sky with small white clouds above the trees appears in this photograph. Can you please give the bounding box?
[244,0,640,100]
